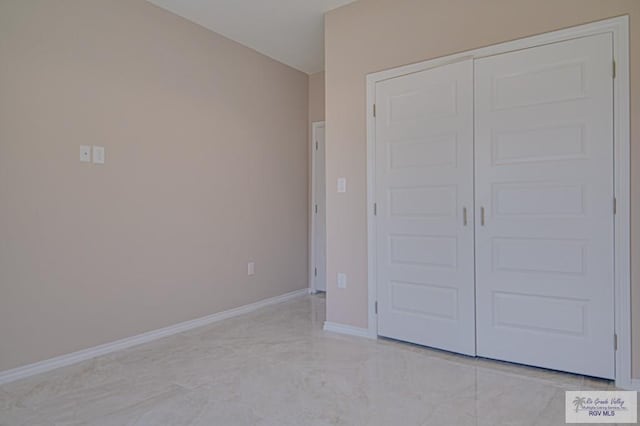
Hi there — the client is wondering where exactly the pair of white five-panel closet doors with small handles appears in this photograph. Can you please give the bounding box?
[375,34,615,378]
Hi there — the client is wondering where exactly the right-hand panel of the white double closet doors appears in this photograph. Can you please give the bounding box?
[475,34,614,378]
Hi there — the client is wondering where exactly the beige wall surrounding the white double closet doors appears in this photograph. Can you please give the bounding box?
[325,0,640,376]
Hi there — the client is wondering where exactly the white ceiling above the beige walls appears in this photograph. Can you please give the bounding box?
[149,0,354,74]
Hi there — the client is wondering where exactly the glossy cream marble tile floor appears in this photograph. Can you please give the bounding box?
[0,295,614,426]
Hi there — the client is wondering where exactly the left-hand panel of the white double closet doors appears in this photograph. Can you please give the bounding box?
[375,60,475,355]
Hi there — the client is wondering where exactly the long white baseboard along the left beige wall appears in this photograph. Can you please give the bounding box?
[0,288,309,385]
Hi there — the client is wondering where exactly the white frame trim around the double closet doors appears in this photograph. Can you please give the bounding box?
[366,15,638,389]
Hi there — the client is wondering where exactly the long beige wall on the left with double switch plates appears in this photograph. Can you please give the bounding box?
[0,0,308,371]
